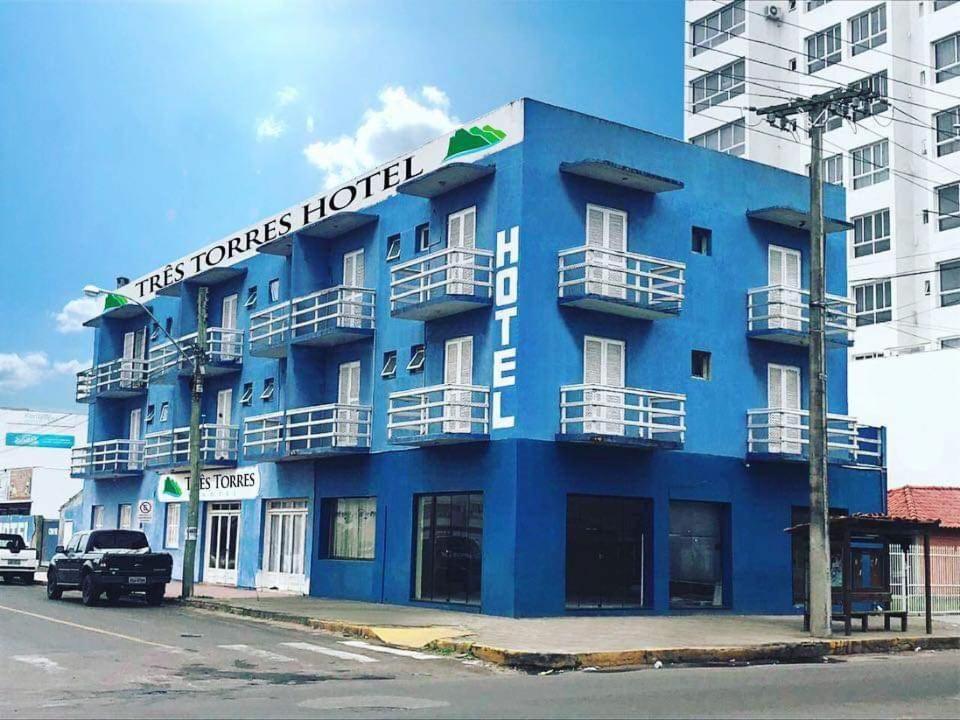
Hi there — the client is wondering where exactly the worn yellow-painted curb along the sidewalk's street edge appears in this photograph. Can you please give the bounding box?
[185,598,960,671]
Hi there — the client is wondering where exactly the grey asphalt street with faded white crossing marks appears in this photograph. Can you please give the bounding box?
[0,584,960,718]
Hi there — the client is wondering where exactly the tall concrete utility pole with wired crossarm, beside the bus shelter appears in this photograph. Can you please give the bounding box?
[750,88,877,638]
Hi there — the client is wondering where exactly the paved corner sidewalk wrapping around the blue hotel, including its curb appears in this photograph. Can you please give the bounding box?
[176,586,960,669]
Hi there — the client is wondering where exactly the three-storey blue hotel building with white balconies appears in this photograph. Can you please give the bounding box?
[73,100,886,616]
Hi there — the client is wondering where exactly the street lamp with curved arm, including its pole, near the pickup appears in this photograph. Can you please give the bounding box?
[83,285,207,600]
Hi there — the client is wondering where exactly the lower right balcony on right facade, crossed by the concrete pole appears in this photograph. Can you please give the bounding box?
[747,408,884,467]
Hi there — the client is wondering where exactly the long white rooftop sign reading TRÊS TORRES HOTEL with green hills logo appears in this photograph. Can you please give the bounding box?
[118,100,523,302]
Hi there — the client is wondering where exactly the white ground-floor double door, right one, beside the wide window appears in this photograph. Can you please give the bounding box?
[257,500,308,594]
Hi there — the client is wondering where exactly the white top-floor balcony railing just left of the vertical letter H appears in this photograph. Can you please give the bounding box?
[390,248,493,313]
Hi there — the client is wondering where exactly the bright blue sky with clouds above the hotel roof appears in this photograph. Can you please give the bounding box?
[0,0,683,409]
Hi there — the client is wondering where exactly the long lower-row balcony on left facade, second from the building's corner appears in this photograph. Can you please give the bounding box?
[243,403,373,461]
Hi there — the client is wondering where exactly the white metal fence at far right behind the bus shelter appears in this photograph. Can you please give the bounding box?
[890,545,960,615]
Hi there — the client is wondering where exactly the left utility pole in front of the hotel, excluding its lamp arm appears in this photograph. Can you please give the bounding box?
[180,285,207,600]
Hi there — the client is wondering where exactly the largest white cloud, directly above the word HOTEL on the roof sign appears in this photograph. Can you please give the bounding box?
[303,86,459,187]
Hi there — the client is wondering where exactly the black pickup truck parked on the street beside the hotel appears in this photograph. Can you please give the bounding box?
[47,530,173,605]
